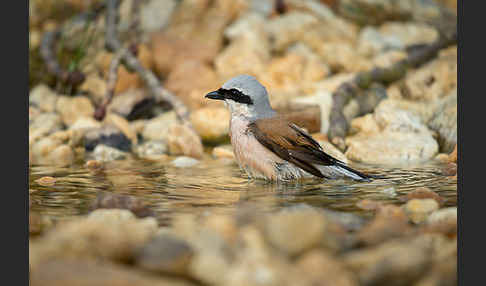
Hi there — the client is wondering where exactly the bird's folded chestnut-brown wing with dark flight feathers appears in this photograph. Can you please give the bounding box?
[248,117,348,178]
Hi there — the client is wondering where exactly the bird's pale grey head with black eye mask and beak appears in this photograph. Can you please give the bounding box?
[205,75,275,119]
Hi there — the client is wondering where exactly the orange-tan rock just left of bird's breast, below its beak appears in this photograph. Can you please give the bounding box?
[190,107,231,144]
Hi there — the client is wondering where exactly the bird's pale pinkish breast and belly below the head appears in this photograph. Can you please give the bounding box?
[230,117,283,179]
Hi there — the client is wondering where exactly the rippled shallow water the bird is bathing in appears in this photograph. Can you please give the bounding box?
[29,156,457,224]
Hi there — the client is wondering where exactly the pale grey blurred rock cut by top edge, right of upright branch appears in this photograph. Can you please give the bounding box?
[139,0,176,33]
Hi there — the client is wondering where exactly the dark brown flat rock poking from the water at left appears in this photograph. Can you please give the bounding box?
[90,193,154,218]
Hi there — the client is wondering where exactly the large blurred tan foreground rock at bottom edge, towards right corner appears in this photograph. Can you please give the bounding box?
[343,239,433,285]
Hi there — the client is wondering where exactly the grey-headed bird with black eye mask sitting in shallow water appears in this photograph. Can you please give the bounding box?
[205,75,372,181]
